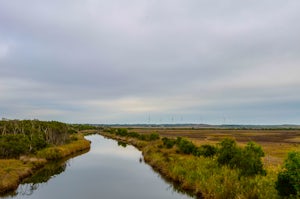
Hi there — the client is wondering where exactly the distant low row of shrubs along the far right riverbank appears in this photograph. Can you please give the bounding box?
[105,128,160,141]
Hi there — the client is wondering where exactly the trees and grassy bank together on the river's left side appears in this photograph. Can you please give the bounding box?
[0,120,90,193]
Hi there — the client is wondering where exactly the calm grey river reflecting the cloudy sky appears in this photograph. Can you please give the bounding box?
[4,135,191,199]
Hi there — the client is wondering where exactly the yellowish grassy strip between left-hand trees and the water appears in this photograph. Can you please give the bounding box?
[0,135,90,194]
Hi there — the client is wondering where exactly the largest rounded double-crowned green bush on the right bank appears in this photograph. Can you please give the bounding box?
[217,138,265,176]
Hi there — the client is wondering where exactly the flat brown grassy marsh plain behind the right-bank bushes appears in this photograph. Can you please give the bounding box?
[122,128,300,167]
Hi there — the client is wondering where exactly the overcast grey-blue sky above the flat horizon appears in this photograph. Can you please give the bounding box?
[0,0,300,124]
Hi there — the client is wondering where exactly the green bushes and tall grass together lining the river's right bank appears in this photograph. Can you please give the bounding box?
[103,129,300,199]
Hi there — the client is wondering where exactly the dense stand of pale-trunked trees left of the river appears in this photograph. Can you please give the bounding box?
[0,120,75,158]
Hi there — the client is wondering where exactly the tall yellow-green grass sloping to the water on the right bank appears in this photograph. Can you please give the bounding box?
[101,132,279,199]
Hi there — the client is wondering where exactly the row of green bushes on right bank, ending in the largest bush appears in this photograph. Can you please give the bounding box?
[162,137,265,176]
